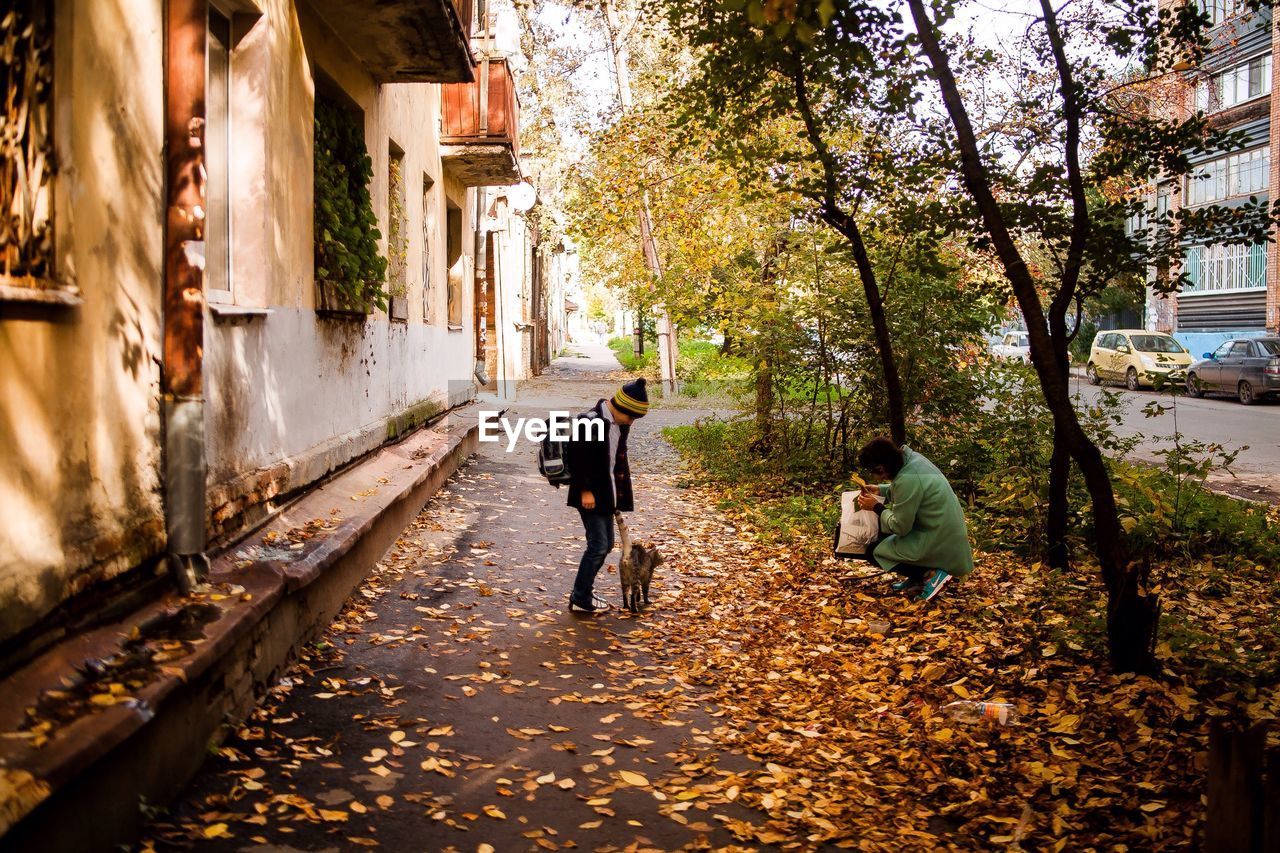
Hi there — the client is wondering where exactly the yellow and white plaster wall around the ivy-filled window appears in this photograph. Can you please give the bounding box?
[205,0,475,535]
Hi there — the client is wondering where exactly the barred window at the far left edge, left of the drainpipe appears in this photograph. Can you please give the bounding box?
[0,0,56,287]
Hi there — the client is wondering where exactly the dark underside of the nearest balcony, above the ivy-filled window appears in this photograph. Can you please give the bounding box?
[310,0,475,83]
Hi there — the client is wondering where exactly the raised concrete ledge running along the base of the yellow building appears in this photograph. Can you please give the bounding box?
[0,405,479,853]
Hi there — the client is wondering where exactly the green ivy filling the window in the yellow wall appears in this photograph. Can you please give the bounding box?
[315,95,388,311]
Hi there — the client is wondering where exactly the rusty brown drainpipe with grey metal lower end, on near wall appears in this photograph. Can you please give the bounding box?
[161,0,209,594]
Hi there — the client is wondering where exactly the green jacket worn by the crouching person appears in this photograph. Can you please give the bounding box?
[876,447,973,578]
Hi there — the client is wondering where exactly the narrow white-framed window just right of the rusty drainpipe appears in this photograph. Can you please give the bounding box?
[205,5,233,302]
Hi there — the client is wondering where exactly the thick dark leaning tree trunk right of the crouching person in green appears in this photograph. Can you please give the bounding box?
[908,0,1160,671]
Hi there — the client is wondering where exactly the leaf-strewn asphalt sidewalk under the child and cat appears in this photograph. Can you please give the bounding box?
[148,347,751,853]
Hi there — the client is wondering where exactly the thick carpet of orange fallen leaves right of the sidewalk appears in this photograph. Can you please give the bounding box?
[660,527,1280,850]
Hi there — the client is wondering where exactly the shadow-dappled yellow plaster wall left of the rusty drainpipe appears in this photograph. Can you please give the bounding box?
[0,0,164,640]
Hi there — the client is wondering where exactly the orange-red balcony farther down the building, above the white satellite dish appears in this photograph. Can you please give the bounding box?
[440,59,521,187]
